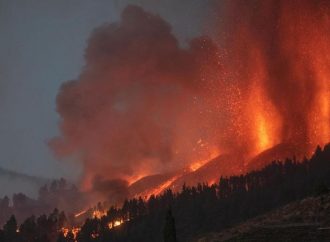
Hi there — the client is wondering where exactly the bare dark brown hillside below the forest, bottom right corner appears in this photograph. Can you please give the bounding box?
[196,193,330,242]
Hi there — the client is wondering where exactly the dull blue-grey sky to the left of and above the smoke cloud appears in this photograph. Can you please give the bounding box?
[0,0,210,186]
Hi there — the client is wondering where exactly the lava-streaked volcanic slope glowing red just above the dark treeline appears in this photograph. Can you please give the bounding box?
[129,143,318,198]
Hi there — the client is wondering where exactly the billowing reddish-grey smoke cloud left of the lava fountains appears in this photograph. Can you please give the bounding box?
[50,6,222,189]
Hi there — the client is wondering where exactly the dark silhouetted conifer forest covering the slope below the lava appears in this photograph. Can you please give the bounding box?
[0,144,330,242]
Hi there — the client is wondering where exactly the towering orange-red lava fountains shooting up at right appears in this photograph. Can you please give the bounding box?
[214,0,330,157]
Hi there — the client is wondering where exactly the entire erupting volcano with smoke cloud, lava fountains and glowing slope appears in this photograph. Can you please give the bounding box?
[50,0,330,204]
